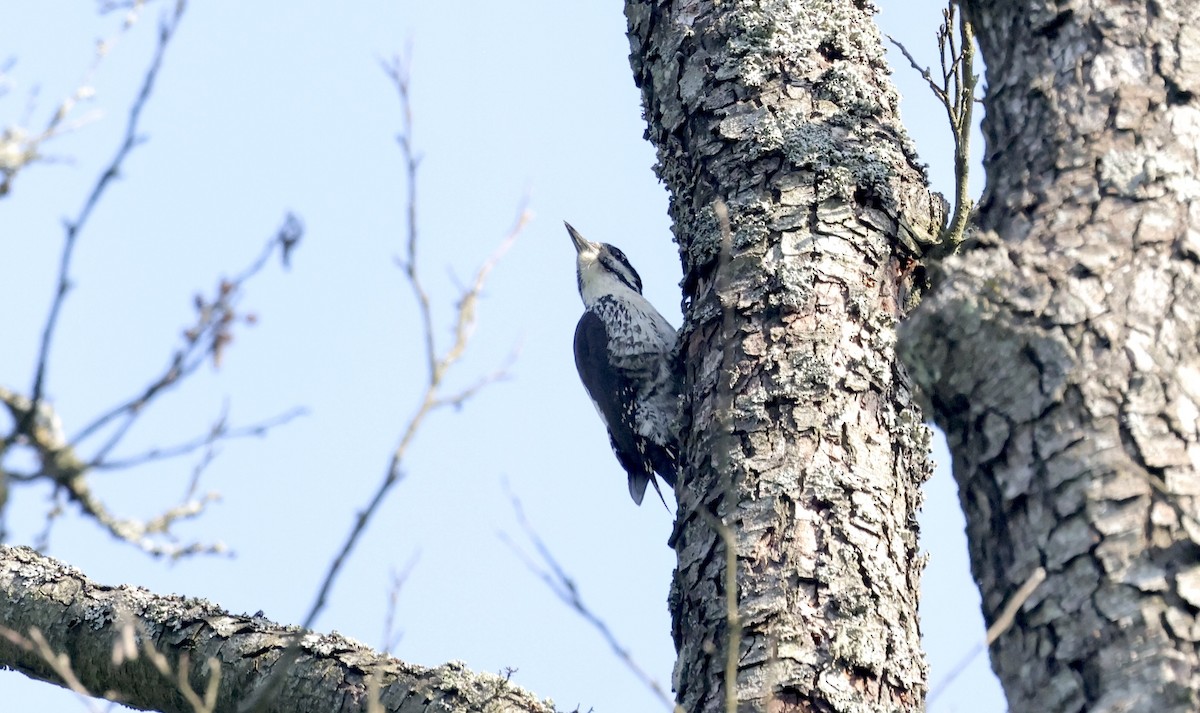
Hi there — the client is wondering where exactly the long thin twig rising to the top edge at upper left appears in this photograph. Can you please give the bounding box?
[26,0,187,431]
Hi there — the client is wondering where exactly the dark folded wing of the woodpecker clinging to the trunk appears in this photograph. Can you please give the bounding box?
[575,310,654,504]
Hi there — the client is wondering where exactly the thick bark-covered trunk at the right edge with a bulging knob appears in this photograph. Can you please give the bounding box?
[901,0,1200,713]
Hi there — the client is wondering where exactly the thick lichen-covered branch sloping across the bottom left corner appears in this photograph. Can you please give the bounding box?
[0,545,554,713]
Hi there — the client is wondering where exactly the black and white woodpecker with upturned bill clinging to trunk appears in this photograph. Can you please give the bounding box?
[564,221,679,505]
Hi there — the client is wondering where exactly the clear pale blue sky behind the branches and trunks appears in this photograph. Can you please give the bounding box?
[0,0,1004,713]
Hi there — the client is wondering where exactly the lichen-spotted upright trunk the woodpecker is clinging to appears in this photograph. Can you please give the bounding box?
[625,0,944,713]
